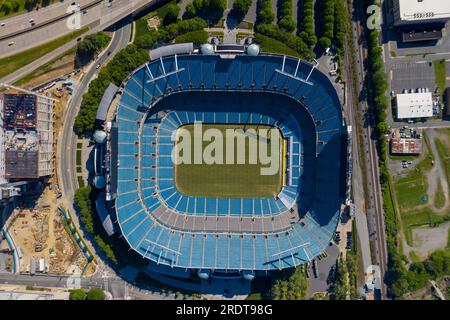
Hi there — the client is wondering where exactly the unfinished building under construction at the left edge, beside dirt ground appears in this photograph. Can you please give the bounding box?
[0,93,53,181]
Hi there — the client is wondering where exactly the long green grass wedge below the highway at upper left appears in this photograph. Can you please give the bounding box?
[0,27,88,78]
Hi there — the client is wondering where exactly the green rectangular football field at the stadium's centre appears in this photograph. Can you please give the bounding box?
[175,124,283,198]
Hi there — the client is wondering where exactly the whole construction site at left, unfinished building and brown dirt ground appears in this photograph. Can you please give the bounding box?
[0,78,95,275]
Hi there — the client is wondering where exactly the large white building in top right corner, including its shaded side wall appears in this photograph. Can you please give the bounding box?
[393,0,450,26]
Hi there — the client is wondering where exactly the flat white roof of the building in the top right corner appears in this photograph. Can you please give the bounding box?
[398,0,450,22]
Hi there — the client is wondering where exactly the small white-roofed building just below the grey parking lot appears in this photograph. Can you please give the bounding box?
[396,92,433,119]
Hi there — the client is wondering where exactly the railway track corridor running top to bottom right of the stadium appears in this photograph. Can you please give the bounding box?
[347,0,387,299]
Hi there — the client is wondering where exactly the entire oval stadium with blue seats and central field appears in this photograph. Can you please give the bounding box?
[96,44,347,288]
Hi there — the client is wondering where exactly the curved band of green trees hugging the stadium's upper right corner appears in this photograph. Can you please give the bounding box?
[256,24,314,60]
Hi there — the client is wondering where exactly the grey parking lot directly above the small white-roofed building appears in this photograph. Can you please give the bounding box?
[391,61,436,94]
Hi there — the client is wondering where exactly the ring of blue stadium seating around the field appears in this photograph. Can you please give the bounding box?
[115,55,342,271]
